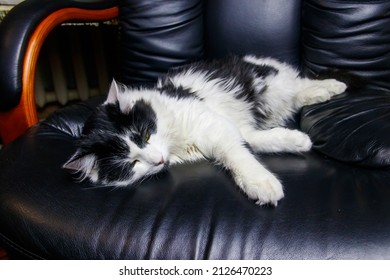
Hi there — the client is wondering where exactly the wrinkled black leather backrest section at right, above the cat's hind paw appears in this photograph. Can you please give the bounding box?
[302,0,390,91]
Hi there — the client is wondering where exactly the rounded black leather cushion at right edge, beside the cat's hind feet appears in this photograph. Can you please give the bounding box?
[301,90,390,167]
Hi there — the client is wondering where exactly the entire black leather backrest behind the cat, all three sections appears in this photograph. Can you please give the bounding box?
[119,0,390,90]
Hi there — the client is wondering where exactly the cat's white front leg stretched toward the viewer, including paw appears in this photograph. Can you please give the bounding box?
[196,118,284,206]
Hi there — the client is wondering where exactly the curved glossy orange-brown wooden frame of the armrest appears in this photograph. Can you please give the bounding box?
[0,7,119,144]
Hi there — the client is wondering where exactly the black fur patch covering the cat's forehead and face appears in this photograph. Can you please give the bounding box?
[78,100,157,184]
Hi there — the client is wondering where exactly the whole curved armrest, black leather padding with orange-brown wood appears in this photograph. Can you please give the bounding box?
[0,0,118,143]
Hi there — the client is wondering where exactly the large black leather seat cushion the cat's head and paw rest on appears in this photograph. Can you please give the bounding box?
[0,100,390,259]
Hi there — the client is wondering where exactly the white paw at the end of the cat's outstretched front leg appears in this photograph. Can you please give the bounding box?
[238,172,284,206]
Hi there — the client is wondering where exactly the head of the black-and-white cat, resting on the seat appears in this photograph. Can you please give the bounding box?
[63,81,168,186]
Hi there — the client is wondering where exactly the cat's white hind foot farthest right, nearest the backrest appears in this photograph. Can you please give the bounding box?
[294,79,347,108]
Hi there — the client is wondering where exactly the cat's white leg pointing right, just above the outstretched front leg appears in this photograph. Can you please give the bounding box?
[244,127,312,153]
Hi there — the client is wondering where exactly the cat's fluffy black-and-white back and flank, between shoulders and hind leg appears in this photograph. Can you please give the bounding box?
[157,55,298,130]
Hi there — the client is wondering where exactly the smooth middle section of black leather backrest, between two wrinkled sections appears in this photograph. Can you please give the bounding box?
[204,0,301,66]
